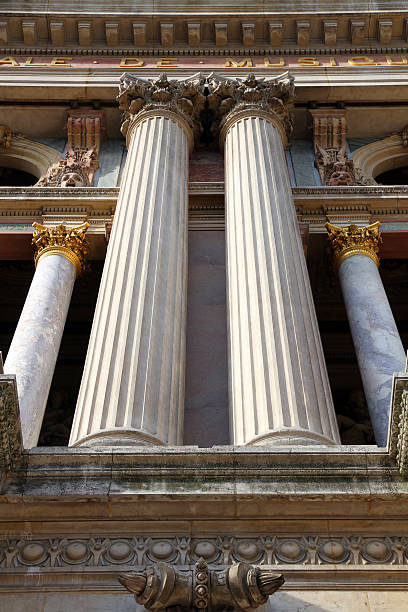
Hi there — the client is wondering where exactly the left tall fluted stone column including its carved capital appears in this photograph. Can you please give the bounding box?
[70,74,204,446]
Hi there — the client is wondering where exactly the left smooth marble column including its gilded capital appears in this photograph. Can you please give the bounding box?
[4,223,88,448]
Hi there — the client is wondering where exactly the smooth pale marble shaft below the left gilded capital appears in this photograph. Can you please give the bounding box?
[4,254,76,448]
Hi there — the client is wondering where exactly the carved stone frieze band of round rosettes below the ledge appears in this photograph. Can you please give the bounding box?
[0,533,408,571]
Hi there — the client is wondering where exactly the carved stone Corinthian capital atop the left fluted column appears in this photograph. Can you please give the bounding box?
[117,72,205,145]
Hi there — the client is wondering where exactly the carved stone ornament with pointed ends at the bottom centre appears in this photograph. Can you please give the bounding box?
[119,559,284,612]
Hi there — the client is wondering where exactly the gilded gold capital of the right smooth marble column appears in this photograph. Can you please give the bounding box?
[325,221,382,270]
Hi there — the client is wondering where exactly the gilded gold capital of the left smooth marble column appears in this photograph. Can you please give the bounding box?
[33,222,89,275]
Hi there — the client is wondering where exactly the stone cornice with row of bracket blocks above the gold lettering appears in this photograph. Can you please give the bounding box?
[0,11,407,54]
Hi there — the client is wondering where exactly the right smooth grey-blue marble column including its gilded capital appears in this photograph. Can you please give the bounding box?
[326,222,406,446]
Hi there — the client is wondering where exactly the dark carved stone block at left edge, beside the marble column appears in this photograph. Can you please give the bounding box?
[0,374,23,470]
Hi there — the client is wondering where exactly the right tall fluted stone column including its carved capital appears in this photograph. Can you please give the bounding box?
[210,74,339,445]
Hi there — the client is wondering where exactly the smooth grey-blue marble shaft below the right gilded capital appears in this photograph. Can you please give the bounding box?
[338,255,405,446]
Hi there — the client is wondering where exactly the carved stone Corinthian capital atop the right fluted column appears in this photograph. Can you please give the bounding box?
[207,72,295,143]
